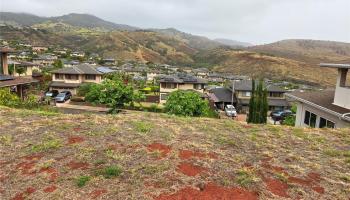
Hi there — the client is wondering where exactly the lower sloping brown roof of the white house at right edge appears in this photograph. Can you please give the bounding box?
[286,90,350,114]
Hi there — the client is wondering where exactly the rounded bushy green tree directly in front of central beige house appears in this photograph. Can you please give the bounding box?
[165,90,210,117]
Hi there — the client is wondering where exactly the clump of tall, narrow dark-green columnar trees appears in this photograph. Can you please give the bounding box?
[247,80,269,124]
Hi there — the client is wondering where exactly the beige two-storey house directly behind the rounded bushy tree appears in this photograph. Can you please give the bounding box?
[159,75,207,103]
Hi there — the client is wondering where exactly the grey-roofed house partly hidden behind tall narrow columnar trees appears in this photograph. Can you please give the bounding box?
[229,80,290,113]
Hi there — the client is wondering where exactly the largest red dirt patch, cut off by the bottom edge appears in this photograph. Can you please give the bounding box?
[155,183,258,200]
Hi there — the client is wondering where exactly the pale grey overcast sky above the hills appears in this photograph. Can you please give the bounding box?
[0,0,350,44]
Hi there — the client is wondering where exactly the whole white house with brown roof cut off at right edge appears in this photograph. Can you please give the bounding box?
[287,64,350,128]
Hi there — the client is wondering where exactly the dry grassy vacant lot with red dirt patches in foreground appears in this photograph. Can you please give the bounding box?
[0,107,350,200]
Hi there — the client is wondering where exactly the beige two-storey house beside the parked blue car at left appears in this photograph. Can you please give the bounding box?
[50,64,103,95]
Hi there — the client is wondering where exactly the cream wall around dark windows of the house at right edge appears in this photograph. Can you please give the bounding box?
[295,103,350,128]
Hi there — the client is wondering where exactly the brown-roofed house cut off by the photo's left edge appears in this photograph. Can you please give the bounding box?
[0,47,38,98]
